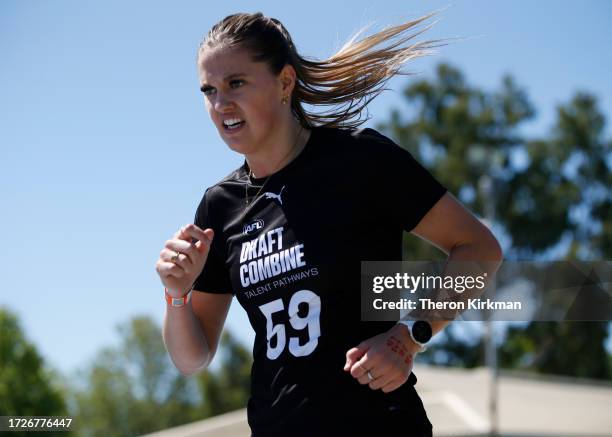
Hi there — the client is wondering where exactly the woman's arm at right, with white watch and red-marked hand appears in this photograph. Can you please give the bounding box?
[344,191,503,393]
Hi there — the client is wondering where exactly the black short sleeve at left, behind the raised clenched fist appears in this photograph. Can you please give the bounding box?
[193,189,232,294]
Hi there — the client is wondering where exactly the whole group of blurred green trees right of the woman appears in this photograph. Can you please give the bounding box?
[378,64,612,377]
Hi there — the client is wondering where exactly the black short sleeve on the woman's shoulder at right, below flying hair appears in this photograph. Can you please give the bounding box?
[358,128,447,232]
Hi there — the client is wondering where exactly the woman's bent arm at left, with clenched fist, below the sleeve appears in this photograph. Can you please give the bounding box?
[156,224,232,375]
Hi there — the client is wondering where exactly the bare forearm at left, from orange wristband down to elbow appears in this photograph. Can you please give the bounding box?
[163,302,211,375]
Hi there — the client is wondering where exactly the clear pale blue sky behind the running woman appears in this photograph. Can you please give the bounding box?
[0,0,612,372]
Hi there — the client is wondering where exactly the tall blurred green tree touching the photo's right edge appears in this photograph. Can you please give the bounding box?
[500,92,612,379]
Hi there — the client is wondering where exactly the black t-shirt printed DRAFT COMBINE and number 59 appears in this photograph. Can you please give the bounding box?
[194,127,446,437]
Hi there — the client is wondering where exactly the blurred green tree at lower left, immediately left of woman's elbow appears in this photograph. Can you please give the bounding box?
[74,317,201,436]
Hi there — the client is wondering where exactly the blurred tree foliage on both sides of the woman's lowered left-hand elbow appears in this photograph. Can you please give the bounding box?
[63,317,251,436]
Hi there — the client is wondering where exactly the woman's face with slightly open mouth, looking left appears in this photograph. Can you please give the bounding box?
[198,46,289,155]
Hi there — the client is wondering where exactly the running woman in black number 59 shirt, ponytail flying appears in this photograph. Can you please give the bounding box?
[156,13,501,437]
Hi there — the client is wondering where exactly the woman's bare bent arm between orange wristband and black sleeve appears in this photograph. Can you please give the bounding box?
[163,290,232,375]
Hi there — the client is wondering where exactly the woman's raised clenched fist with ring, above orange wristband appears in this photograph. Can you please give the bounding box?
[155,224,214,297]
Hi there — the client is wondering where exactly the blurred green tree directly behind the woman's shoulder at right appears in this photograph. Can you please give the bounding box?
[378,64,535,260]
